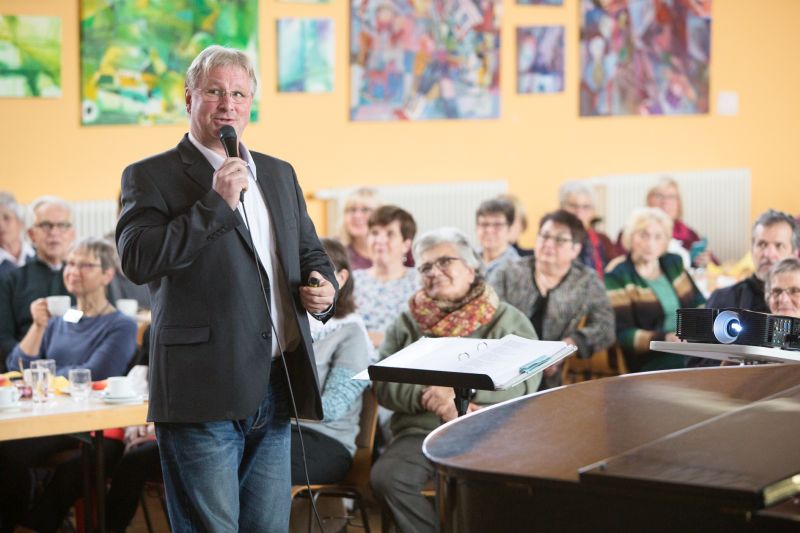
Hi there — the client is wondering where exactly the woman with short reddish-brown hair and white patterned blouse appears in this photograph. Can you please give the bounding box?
[353,205,418,347]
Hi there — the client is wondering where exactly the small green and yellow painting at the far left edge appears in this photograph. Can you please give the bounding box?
[0,15,61,98]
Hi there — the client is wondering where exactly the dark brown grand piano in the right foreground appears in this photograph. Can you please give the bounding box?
[423,364,800,533]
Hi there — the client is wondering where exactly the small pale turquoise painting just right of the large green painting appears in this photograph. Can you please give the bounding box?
[278,18,334,93]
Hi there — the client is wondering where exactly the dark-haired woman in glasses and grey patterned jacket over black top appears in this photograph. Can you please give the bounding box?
[489,210,614,388]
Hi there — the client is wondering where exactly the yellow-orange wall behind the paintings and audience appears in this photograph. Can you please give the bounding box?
[0,0,800,241]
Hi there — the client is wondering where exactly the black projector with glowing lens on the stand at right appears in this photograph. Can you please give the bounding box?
[676,308,800,350]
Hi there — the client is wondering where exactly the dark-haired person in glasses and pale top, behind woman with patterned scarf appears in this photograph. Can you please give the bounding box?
[475,199,519,277]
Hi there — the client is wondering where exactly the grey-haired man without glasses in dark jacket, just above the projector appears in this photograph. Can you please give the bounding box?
[706,209,798,313]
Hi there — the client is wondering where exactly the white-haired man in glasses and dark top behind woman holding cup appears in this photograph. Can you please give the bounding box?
[0,196,75,366]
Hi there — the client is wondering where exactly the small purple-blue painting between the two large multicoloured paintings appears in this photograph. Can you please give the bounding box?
[517,26,564,93]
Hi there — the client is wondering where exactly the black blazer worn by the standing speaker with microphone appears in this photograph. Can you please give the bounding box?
[116,136,338,422]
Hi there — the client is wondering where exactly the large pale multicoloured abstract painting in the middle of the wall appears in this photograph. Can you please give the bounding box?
[350,0,500,120]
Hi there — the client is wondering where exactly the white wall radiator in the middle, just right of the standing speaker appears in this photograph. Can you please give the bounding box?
[314,180,508,244]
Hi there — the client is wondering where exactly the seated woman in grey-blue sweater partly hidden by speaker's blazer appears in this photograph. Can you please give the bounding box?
[292,239,372,485]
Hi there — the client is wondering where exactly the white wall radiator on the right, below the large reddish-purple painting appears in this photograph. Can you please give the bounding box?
[587,169,752,261]
